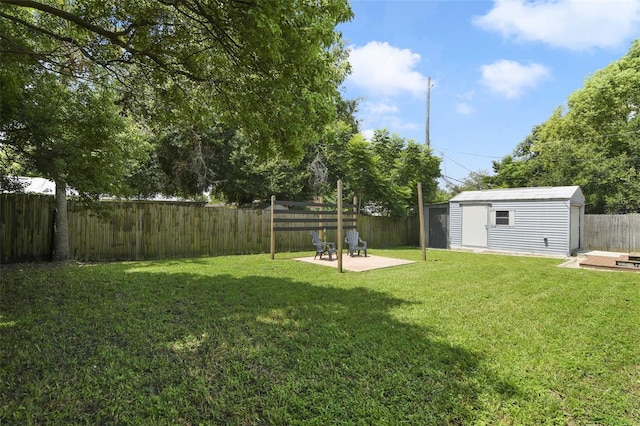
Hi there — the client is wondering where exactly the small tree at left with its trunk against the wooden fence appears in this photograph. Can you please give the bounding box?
[0,57,144,260]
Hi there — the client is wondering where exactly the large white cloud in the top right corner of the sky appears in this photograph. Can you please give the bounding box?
[473,0,640,50]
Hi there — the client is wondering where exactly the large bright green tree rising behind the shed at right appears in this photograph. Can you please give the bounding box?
[492,41,640,213]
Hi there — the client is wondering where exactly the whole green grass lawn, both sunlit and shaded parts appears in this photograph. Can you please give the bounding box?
[0,249,640,425]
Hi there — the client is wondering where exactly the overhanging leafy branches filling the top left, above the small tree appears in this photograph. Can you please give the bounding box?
[0,0,352,156]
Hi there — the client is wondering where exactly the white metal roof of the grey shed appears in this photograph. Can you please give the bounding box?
[450,186,584,203]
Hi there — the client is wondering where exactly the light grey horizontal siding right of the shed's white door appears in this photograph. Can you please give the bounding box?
[488,201,570,256]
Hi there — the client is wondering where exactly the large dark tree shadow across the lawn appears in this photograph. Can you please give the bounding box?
[0,265,516,424]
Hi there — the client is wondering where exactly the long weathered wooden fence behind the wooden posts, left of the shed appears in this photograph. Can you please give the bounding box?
[0,194,418,263]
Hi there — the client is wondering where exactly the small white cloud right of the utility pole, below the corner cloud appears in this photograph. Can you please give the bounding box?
[482,60,550,98]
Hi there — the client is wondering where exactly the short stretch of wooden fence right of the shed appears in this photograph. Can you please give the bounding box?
[584,213,640,253]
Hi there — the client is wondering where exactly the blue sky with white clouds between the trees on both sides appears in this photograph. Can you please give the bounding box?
[338,0,640,183]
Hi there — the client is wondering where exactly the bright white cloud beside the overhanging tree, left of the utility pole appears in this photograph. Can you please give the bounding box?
[347,41,427,96]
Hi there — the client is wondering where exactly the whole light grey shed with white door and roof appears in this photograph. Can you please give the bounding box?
[449,186,585,256]
